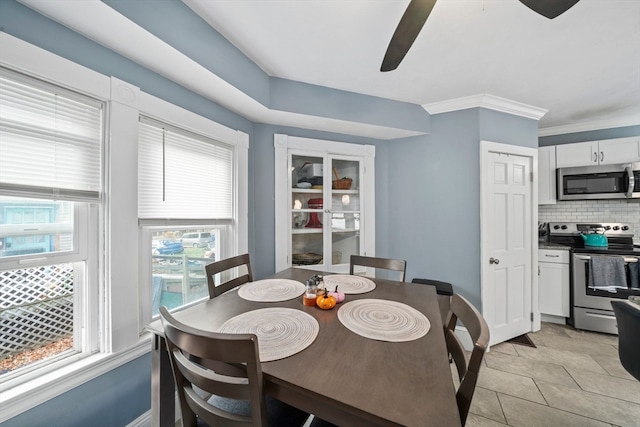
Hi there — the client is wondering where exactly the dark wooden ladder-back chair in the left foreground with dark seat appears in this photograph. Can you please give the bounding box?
[160,306,309,427]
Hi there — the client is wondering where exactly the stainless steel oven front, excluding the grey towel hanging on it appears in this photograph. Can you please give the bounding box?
[572,253,640,334]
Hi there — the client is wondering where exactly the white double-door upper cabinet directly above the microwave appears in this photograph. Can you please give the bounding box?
[556,136,640,168]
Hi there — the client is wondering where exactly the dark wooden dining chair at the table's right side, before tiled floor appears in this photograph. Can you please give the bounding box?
[444,294,489,425]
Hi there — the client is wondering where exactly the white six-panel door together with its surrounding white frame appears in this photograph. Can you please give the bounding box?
[480,141,540,345]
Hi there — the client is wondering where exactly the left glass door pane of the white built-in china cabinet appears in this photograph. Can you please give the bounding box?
[290,155,325,266]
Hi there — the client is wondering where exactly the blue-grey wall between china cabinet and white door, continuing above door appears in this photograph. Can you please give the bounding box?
[376,108,538,307]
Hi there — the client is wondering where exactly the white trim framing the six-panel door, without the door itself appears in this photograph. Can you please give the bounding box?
[480,140,540,345]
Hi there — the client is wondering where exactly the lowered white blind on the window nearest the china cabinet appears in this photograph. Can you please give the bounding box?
[138,117,234,219]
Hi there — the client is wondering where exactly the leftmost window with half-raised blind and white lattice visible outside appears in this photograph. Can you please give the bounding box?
[0,68,104,384]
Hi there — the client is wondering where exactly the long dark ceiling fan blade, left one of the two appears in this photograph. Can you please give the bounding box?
[380,0,436,71]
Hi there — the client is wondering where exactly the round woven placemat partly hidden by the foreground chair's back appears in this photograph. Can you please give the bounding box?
[218,307,320,362]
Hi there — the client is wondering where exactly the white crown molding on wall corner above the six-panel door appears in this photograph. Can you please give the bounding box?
[422,93,549,120]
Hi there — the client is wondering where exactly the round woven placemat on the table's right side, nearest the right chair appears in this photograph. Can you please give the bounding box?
[338,299,431,342]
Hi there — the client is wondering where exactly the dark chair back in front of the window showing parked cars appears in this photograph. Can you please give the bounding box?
[204,254,253,298]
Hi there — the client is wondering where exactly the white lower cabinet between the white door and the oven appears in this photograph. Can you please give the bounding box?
[538,249,570,323]
